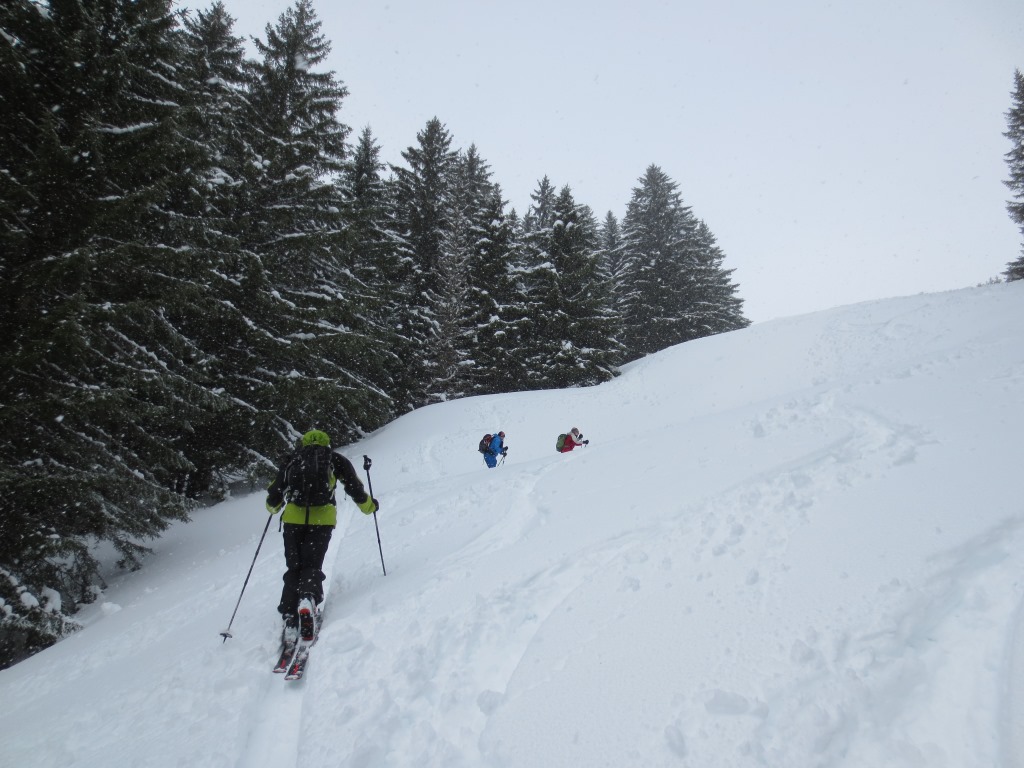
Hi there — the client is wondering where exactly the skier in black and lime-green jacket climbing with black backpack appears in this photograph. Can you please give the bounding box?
[266,429,380,671]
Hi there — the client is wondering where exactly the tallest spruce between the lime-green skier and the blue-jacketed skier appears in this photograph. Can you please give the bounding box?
[392,118,458,408]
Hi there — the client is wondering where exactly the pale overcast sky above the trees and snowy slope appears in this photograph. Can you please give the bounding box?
[182,0,1024,322]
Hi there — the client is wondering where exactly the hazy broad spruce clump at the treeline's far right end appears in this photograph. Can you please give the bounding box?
[617,165,746,359]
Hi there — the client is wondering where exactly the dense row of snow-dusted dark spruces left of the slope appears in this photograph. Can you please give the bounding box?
[0,0,748,665]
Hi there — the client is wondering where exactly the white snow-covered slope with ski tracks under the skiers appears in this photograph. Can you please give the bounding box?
[0,283,1024,768]
